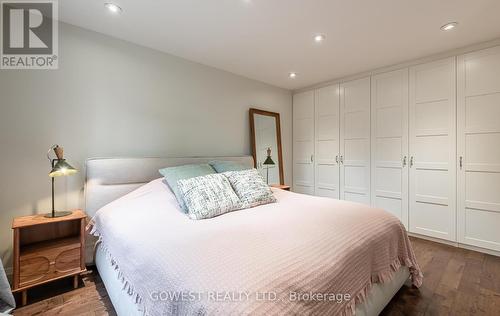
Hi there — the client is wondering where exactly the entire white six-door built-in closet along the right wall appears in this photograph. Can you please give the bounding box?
[293,47,500,254]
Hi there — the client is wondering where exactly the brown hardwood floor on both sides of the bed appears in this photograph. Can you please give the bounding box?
[14,238,500,316]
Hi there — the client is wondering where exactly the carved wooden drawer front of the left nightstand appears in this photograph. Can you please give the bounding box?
[19,238,82,287]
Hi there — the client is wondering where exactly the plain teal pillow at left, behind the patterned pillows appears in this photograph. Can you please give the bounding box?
[158,164,215,212]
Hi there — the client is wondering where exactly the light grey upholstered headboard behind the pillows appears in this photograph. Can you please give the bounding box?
[85,156,254,217]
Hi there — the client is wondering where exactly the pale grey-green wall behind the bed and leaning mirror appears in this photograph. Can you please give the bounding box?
[0,24,292,267]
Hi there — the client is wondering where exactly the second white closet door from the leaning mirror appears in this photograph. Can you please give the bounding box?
[314,85,340,199]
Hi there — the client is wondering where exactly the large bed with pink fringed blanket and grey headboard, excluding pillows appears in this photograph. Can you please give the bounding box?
[85,156,422,315]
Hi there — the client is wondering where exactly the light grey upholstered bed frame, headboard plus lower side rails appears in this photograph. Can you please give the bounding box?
[85,156,409,316]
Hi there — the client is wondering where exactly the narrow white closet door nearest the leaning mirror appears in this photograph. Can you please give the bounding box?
[293,91,314,194]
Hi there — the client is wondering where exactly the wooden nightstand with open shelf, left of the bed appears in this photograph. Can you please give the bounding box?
[12,210,87,305]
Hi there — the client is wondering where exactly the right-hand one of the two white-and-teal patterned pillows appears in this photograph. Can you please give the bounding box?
[223,169,276,208]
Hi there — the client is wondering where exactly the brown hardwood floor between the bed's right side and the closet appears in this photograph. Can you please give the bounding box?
[382,238,500,315]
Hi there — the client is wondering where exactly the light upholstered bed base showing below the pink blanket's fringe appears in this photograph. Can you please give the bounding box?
[95,246,410,316]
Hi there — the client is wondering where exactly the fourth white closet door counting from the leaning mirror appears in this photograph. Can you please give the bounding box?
[371,69,408,227]
